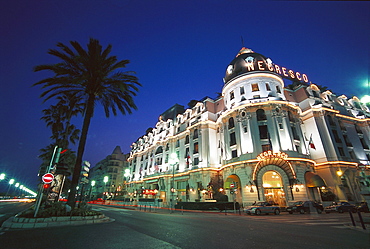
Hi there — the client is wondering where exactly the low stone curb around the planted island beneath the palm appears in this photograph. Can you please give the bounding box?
[1,214,115,229]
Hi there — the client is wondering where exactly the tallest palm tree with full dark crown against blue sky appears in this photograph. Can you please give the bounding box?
[34,38,141,208]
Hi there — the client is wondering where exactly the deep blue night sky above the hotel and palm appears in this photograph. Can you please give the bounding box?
[0,0,370,191]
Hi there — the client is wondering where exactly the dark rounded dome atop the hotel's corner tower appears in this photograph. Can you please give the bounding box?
[224,47,275,84]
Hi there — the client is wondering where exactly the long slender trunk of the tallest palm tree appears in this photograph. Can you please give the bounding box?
[68,95,95,209]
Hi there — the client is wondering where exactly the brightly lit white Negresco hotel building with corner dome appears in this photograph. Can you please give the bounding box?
[128,48,370,206]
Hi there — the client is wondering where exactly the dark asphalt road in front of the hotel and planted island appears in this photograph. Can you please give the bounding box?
[0,206,370,249]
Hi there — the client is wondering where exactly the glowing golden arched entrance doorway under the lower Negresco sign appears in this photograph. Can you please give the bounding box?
[262,170,286,206]
